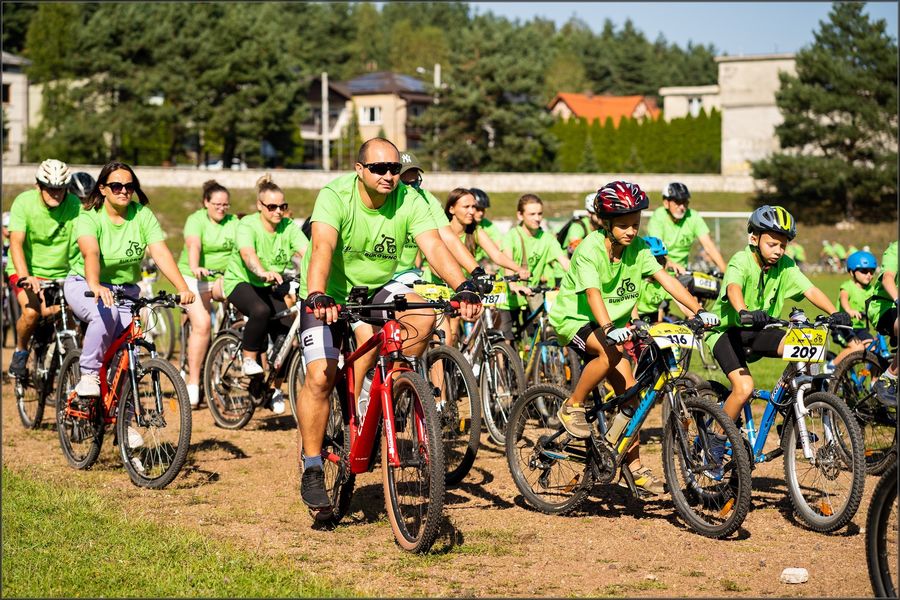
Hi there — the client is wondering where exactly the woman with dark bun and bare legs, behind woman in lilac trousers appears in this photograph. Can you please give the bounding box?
[178,179,238,407]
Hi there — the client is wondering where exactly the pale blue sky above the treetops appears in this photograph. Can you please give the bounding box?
[469,1,898,56]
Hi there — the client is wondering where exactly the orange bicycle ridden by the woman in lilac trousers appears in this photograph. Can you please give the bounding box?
[56,291,191,489]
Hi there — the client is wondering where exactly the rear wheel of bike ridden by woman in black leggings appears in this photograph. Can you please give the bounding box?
[203,331,256,429]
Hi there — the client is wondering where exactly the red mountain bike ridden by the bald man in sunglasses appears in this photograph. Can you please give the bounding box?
[307,288,459,552]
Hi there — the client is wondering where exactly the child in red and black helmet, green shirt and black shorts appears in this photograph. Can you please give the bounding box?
[549,181,718,494]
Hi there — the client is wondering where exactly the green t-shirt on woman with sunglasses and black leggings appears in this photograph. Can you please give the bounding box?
[223,213,309,296]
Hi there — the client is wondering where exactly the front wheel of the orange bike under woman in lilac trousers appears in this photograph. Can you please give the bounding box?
[116,358,191,489]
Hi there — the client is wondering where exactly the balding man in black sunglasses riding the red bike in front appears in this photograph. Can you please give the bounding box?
[297,138,481,512]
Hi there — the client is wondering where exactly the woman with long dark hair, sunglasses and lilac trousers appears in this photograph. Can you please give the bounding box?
[63,162,194,397]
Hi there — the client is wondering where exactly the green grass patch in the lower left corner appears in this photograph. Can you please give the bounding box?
[2,467,354,598]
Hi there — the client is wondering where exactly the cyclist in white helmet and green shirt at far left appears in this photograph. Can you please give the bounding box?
[6,158,81,377]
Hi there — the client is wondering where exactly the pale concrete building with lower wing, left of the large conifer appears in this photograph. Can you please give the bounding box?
[659,54,797,176]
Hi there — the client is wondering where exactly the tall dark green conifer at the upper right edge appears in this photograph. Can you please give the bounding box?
[752,2,898,221]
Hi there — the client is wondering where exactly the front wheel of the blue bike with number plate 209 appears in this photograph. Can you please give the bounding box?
[781,392,866,533]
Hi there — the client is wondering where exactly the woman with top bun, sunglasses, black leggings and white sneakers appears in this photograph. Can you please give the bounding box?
[224,173,309,414]
